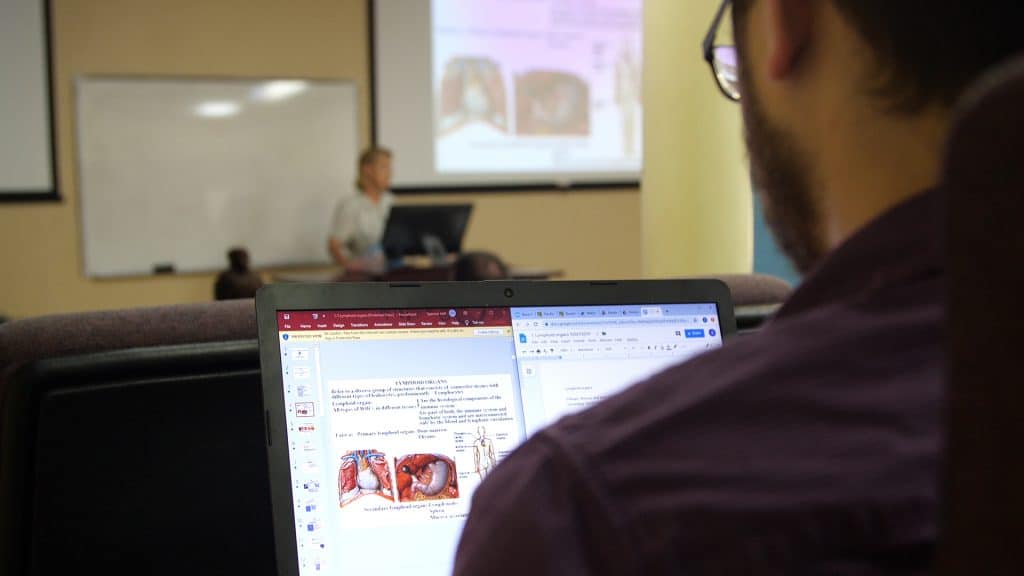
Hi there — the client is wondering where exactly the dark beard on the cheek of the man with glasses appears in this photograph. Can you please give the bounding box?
[739,59,827,275]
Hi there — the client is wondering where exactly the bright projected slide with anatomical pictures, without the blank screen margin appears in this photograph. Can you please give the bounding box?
[431,0,643,174]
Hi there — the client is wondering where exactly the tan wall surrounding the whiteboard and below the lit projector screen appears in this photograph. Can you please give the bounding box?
[0,0,640,317]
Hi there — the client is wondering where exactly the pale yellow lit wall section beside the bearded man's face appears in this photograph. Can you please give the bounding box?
[642,0,754,277]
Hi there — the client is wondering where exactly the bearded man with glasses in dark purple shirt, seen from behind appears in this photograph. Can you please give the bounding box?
[456,0,1024,574]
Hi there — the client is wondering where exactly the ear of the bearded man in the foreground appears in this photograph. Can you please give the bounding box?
[765,0,815,80]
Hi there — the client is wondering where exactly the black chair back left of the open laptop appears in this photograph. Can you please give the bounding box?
[0,340,274,575]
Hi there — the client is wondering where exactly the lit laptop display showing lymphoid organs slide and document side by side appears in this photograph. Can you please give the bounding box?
[278,304,721,574]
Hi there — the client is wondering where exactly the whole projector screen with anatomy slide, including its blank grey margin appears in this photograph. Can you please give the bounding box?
[373,0,643,192]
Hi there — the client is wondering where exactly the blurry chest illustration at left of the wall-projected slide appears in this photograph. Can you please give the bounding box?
[438,57,508,137]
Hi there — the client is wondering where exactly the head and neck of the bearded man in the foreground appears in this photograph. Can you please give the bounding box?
[731,0,1024,273]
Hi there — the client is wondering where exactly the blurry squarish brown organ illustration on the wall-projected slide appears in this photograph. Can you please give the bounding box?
[515,71,590,136]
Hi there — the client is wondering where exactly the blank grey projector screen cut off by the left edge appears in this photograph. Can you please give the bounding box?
[0,0,56,201]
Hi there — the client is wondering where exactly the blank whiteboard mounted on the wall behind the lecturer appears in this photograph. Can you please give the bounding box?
[76,78,358,277]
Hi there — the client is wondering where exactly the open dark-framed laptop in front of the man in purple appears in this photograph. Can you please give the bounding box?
[256,280,735,576]
